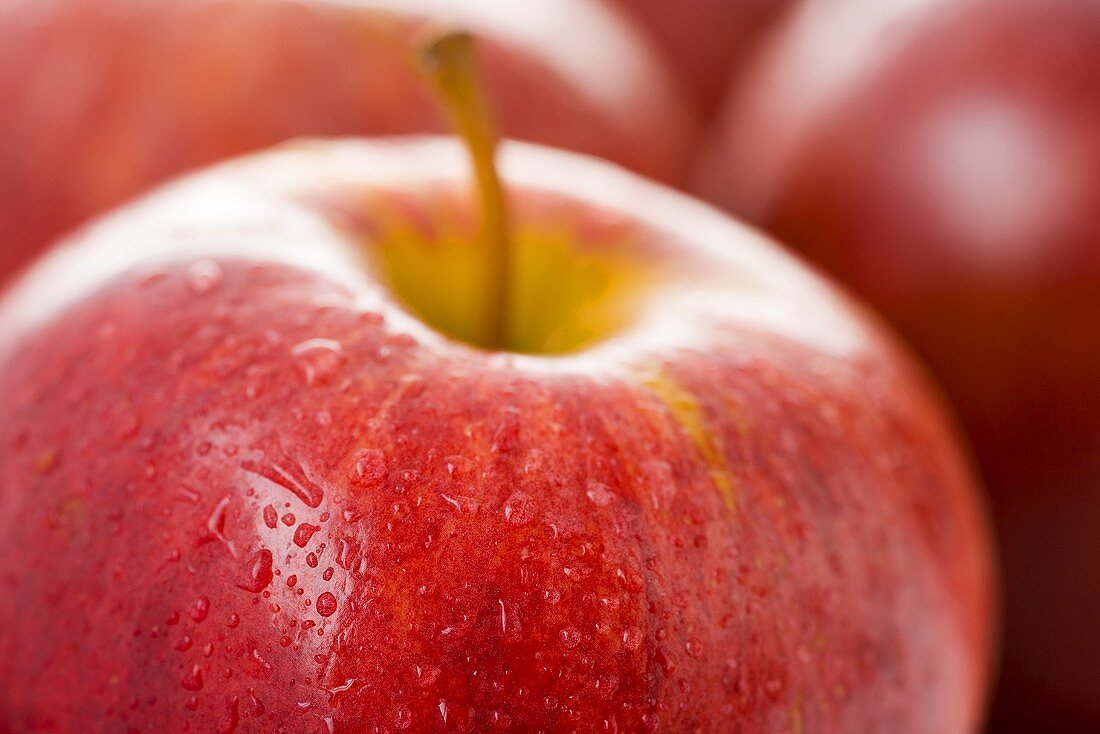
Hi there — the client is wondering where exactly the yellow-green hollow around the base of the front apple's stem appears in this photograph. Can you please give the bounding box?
[369,222,650,354]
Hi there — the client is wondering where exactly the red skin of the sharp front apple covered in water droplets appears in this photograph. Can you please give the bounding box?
[0,139,994,734]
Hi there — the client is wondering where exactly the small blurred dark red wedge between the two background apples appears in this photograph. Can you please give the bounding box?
[605,0,796,111]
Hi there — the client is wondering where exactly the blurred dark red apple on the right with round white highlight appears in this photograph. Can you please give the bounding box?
[703,0,1100,732]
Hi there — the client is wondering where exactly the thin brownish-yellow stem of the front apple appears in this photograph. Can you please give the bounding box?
[421,32,512,349]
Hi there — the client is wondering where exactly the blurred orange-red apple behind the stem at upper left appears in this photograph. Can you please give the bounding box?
[0,0,697,278]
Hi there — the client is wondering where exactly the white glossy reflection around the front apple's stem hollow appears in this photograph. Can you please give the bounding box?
[0,138,872,374]
